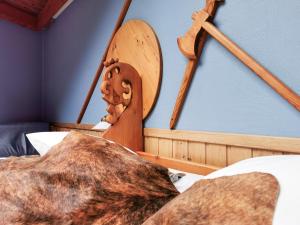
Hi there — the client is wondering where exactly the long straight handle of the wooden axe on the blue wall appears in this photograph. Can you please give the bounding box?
[202,22,300,111]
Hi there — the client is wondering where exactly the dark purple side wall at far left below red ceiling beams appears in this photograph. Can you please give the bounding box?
[0,20,42,123]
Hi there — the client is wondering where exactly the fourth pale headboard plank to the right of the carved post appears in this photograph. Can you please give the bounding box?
[188,142,206,163]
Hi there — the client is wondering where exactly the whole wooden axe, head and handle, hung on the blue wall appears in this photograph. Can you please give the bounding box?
[170,0,300,128]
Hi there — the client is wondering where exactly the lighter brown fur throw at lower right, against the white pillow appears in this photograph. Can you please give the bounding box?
[143,172,279,225]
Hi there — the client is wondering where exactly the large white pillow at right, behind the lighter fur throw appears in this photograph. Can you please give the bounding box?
[205,155,300,225]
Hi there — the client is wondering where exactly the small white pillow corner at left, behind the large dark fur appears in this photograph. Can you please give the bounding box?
[26,131,69,156]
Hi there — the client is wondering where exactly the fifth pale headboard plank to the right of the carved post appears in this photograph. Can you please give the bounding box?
[206,144,227,167]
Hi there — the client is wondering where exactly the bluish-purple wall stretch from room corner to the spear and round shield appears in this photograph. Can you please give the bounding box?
[43,0,122,123]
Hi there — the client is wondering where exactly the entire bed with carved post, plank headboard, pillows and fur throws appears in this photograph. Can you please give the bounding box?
[0,14,300,225]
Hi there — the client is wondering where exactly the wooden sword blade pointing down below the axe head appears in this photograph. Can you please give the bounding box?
[170,31,207,129]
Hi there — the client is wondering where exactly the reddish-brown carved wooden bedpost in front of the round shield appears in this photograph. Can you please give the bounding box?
[101,59,143,151]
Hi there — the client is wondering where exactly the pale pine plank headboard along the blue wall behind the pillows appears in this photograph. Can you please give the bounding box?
[51,123,300,174]
